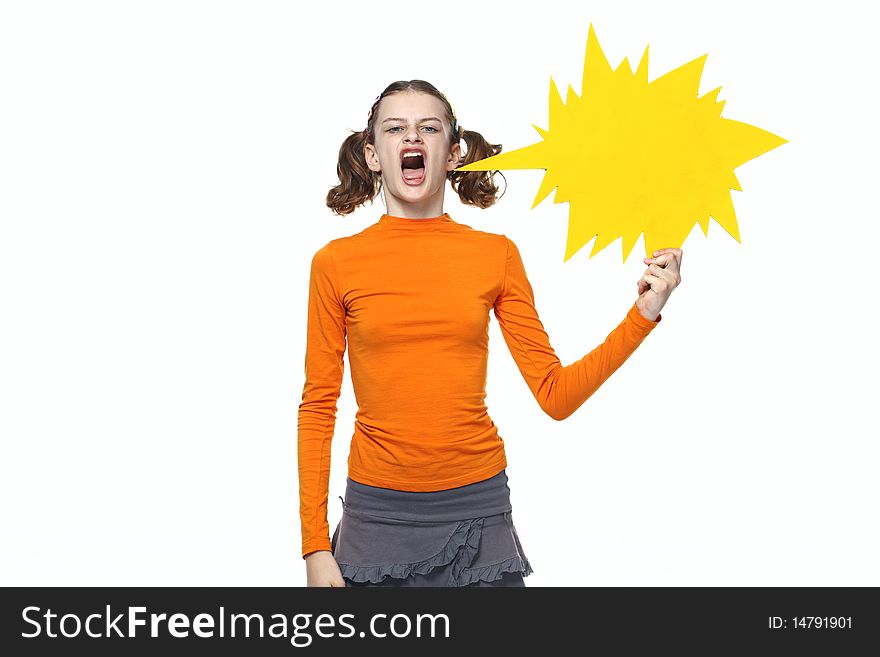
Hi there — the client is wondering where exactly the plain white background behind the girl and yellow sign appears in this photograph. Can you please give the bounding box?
[0,0,880,586]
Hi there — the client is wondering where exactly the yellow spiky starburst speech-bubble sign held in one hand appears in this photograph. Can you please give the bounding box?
[457,24,786,262]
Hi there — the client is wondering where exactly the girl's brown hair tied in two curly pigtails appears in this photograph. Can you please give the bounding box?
[327,80,506,216]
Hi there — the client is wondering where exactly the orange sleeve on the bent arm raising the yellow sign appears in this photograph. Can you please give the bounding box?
[494,236,662,420]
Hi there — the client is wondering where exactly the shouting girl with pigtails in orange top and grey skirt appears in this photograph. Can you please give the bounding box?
[298,80,681,586]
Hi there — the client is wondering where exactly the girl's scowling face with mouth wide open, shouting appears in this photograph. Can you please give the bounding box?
[364,91,461,217]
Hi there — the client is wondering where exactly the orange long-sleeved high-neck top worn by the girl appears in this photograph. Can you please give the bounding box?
[298,213,661,557]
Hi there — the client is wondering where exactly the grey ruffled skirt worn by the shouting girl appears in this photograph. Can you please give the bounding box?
[331,470,533,587]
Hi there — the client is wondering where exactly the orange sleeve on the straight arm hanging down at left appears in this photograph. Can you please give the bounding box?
[297,243,346,557]
